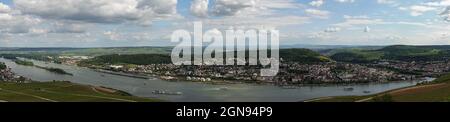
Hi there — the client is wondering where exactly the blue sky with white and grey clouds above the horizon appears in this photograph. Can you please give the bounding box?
[0,0,450,47]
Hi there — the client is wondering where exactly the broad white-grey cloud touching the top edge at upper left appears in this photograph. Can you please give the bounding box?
[14,0,177,23]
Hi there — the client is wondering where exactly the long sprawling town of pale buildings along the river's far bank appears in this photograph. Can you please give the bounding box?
[67,60,450,86]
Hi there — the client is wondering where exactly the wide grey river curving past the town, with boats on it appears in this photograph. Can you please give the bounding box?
[0,58,436,102]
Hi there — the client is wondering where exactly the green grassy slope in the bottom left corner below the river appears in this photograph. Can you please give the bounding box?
[0,82,159,102]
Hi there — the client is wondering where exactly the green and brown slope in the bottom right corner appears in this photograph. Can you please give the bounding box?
[310,74,450,102]
